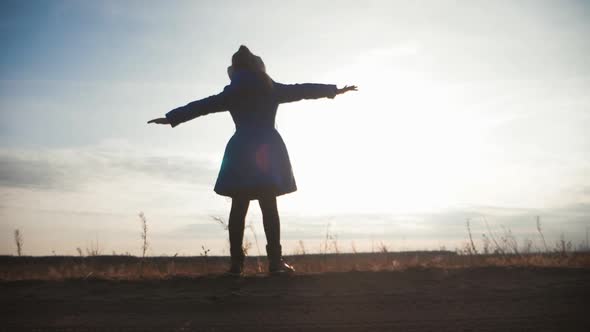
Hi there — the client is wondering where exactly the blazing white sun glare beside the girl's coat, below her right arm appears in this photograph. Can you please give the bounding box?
[278,64,494,213]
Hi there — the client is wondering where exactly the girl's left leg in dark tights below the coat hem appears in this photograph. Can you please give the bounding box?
[228,197,250,265]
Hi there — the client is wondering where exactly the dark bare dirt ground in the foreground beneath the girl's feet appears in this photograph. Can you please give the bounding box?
[0,267,590,332]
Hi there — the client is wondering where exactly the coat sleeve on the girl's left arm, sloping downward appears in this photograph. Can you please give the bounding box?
[166,87,228,128]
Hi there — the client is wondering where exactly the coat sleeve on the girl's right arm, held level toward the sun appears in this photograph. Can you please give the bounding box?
[274,83,338,103]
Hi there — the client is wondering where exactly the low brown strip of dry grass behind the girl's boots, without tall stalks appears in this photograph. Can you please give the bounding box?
[0,251,590,281]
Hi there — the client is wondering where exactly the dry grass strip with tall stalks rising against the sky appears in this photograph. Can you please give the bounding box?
[5,213,590,281]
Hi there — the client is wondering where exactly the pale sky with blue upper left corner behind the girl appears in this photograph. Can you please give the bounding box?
[0,0,590,255]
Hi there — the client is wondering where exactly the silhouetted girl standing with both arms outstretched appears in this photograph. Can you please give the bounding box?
[148,45,357,275]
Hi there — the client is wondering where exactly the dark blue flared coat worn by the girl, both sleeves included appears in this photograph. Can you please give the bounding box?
[166,71,337,199]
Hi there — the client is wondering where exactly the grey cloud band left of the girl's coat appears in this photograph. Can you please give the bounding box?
[0,148,217,191]
